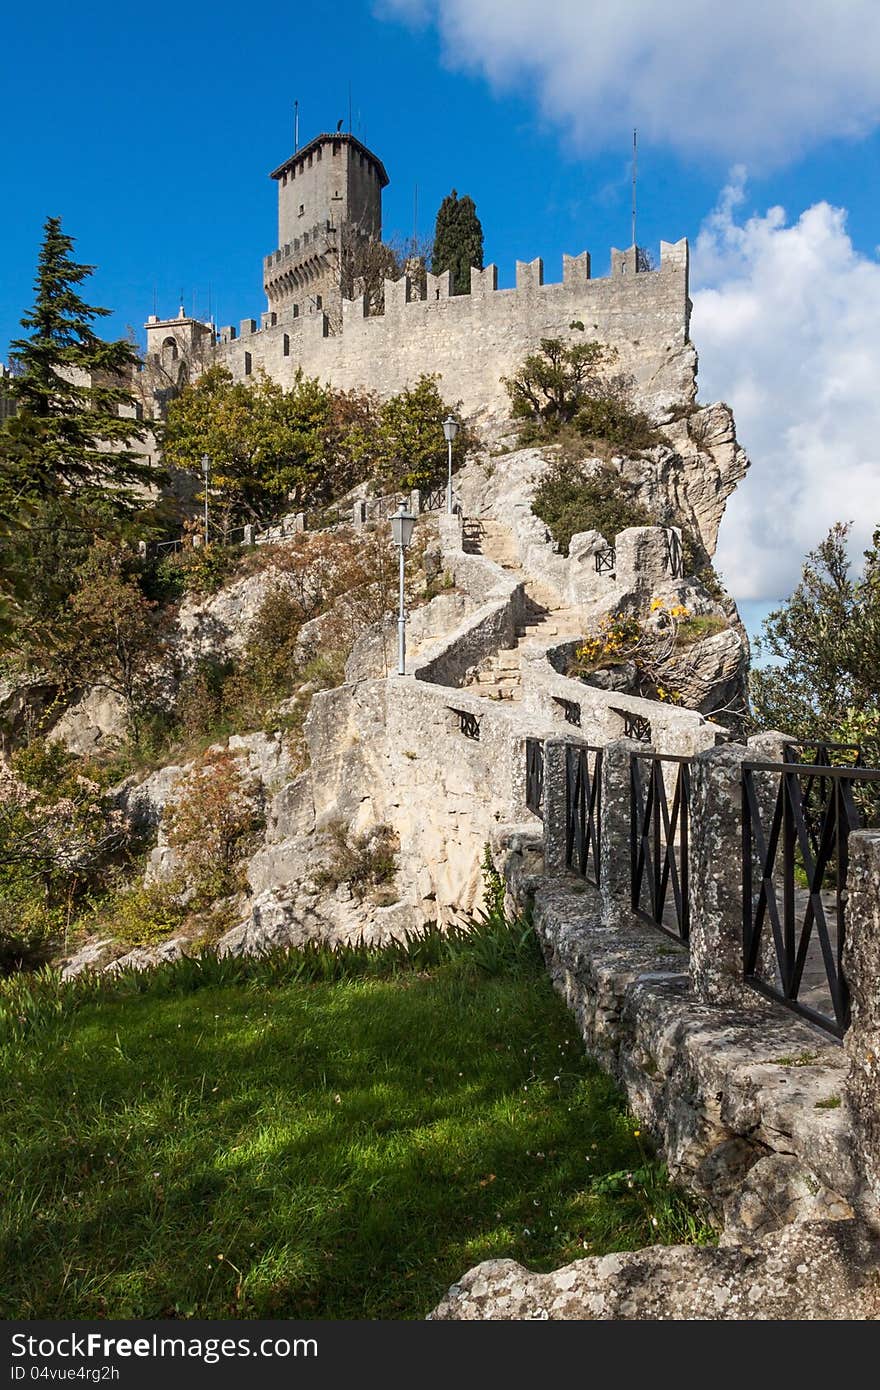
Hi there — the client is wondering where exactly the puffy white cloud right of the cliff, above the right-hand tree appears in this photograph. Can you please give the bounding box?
[691,171,880,598]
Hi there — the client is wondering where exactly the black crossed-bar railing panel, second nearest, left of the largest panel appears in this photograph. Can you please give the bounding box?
[630,753,691,941]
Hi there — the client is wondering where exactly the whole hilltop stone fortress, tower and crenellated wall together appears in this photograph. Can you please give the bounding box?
[140,132,696,433]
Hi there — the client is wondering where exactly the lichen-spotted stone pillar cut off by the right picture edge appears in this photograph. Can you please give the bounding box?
[844,830,880,1229]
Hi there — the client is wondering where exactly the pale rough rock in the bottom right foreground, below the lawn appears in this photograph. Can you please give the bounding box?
[431,1220,880,1322]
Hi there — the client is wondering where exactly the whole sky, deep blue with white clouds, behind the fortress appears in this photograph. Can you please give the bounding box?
[0,0,880,598]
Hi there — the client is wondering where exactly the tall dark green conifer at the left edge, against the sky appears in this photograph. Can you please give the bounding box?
[0,217,158,512]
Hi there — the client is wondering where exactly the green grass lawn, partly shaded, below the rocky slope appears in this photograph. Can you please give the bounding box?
[0,923,710,1318]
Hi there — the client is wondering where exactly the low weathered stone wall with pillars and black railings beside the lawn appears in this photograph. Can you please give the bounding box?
[496,734,880,1233]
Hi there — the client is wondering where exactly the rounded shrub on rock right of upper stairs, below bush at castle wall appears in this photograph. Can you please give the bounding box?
[532,460,658,555]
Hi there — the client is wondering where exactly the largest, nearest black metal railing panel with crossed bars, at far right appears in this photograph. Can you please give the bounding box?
[742,762,880,1037]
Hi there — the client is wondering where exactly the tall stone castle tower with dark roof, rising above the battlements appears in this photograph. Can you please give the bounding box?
[263,132,388,322]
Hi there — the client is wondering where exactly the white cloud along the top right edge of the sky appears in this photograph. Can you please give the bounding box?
[378,0,880,165]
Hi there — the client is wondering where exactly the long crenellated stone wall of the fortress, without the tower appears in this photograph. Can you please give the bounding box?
[191,240,695,425]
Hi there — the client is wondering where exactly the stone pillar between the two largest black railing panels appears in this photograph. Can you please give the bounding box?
[690,744,756,1005]
